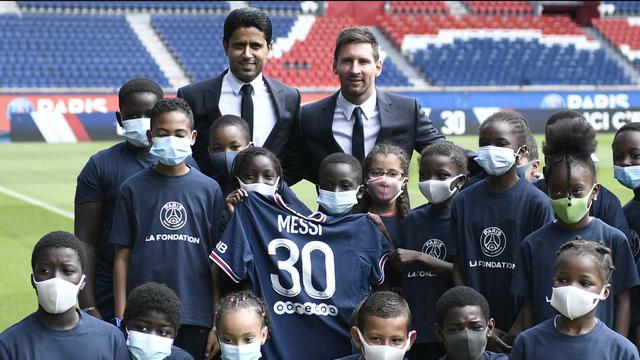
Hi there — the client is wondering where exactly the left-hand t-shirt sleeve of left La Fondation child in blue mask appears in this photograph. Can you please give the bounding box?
[109,183,136,248]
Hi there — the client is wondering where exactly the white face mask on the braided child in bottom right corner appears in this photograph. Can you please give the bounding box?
[550,286,605,320]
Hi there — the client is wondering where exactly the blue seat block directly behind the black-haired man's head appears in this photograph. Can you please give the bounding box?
[151,15,296,81]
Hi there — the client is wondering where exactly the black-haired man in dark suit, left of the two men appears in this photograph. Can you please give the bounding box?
[178,7,300,176]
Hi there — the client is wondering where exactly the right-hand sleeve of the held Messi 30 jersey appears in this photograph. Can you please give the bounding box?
[358,217,391,285]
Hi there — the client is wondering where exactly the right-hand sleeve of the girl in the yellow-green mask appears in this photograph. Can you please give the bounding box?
[612,233,640,295]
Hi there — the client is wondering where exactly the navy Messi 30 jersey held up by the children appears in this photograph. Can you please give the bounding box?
[210,193,391,360]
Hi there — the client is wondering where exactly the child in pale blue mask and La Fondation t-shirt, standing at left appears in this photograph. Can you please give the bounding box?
[110,99,224,359]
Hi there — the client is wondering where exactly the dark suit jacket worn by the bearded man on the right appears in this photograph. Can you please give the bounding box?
[291,89,446,184]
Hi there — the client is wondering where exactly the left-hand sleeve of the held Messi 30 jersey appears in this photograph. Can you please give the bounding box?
[209,203,253,283]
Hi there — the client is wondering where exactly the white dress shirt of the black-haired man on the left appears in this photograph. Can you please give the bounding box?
[218,71,278,146]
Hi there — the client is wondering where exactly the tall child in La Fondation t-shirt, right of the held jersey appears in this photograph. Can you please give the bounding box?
[449,111,553,340]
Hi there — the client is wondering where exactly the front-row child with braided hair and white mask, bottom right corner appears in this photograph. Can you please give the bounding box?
[510,240,640,360]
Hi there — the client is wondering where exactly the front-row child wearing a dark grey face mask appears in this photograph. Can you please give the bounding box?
[435,286,507,360]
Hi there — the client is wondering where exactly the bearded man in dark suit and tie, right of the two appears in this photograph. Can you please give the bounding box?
[291,27,446,183]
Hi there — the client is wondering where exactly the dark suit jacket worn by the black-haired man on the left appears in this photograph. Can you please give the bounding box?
[178,69,300,176]
